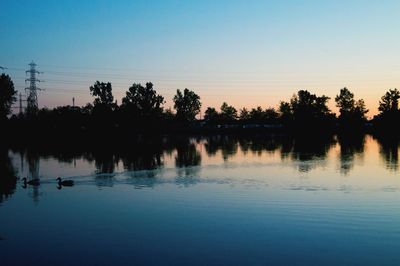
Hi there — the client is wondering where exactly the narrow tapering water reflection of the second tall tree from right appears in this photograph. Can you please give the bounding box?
[338,135,365,175]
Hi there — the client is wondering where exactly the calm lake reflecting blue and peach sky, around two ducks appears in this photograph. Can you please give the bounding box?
[0,135,400,266]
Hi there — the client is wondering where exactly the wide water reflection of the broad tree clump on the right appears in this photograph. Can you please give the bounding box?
[281,136,336,172]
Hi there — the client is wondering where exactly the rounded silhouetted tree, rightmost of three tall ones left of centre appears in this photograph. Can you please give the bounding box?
[173,89,201,122]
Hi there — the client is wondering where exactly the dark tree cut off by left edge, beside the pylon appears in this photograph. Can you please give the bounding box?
[0,73,17,120]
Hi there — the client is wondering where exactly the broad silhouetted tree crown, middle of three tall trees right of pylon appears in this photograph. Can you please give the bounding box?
[122,82,164,117]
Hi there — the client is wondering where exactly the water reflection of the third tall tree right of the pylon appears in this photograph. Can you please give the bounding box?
[175,139,201,176]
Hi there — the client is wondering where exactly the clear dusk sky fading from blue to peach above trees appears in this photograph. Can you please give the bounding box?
[0,0,400,116]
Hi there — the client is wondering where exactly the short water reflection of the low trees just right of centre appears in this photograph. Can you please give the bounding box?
[204,135,238,161]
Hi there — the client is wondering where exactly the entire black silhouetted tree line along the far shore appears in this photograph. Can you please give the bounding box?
[0,71,400,134]
